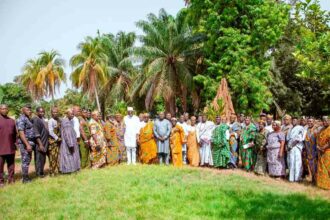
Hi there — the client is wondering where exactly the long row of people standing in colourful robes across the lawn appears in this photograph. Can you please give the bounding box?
[0,105,330,189]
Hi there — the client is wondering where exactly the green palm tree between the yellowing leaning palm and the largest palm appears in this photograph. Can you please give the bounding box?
[102,32,136,104]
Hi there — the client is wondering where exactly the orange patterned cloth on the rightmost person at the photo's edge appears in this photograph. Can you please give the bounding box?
[316,126,330,190]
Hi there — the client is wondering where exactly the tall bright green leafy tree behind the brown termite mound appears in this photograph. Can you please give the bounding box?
[189,0,288,114]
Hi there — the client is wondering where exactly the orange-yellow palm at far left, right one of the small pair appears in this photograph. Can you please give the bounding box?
[35,50,66,102]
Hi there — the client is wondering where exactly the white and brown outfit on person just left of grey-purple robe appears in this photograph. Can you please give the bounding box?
[48,118,61,175]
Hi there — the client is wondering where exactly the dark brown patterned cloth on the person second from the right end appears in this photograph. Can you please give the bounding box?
[305,127,318,182]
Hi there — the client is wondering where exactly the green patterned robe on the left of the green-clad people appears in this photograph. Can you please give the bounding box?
[212,124,230,167]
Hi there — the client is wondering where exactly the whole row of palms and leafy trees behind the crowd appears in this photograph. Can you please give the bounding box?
[11,0,330,116]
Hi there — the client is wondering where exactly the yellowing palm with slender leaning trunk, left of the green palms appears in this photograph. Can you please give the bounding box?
[70,36,108,111]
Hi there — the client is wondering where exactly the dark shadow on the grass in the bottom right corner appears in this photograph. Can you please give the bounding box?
[219,191,330,219]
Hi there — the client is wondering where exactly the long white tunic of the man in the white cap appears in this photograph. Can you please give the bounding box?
[124,115,141,147]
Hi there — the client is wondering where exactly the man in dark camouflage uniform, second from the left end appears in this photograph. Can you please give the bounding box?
[16,105,36,183]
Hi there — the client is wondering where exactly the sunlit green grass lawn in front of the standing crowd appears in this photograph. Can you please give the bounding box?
[0,165,330,219]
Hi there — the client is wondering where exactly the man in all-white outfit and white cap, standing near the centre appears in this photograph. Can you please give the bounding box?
[124,107,140,165]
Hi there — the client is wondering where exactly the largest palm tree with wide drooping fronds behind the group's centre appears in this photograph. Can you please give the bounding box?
[131,9,198,114]
